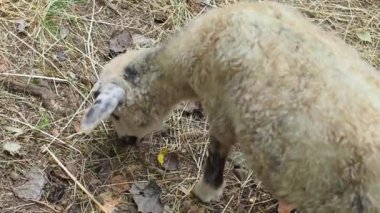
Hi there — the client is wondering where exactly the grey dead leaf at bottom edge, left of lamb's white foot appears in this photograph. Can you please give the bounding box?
[129,181,164,213]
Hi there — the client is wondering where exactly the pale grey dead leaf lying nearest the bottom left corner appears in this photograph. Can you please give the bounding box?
[13,168,46,200]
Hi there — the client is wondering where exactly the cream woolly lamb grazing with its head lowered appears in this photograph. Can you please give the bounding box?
[82,2,380,212]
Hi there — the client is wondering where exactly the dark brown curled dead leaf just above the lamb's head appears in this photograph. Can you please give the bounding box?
[109,29,133,57]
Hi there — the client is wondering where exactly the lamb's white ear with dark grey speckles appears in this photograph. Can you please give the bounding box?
[81,84,125,133]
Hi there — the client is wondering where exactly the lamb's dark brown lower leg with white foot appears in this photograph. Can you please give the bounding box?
[193,135,232,202]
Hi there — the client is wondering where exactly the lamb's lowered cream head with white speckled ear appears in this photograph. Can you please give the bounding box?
[82,49,162,141]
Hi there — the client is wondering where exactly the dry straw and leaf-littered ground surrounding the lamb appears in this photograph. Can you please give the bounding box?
[0,0,380,212]
